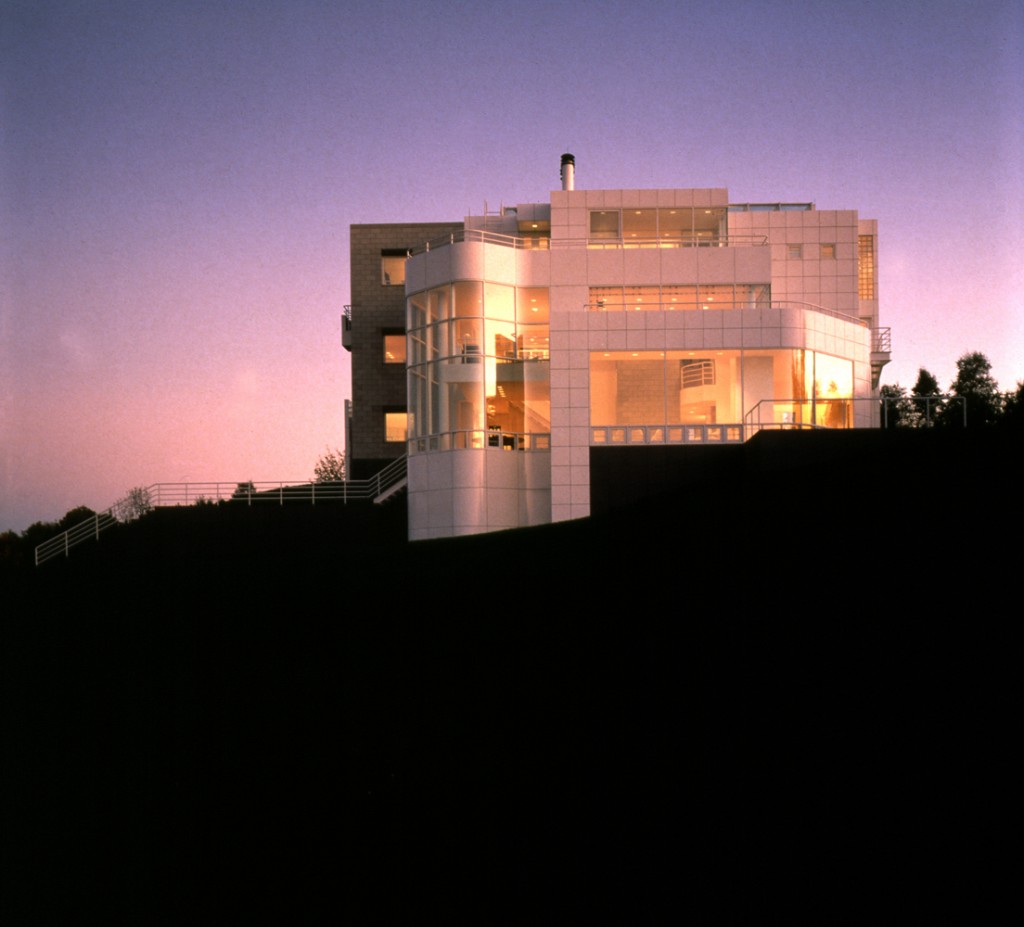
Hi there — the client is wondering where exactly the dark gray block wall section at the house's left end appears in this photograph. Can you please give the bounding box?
[347,222,463,477]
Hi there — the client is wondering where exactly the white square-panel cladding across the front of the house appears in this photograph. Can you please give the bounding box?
[407,183,877,538]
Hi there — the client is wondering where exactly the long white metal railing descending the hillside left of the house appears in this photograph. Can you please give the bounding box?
[36,456,408,566]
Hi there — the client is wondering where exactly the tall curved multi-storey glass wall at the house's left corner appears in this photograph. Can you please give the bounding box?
[408,282,551,452]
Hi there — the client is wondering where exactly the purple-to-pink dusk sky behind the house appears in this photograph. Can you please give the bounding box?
[0,0,1024,531]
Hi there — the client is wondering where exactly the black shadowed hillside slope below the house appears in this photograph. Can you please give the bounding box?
[2,428,1022,923]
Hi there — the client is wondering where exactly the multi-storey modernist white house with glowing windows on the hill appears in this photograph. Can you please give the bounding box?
[347,155,889,540]
